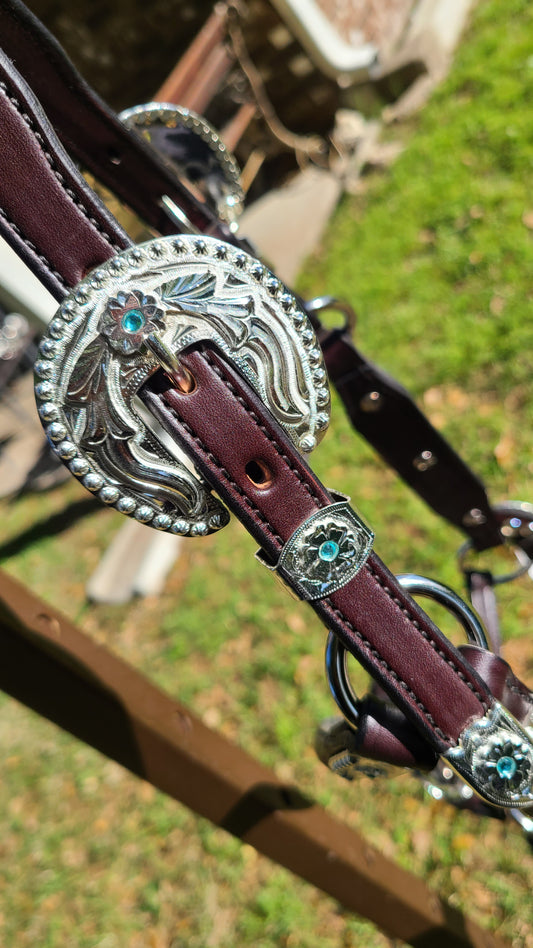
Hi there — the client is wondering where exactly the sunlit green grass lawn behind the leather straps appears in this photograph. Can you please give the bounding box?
[5,0,533,948]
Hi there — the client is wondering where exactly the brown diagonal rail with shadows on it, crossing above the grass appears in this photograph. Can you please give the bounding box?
[0,571,505,948]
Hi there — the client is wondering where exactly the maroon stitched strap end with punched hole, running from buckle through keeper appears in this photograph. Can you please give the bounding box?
[142,351,491,752]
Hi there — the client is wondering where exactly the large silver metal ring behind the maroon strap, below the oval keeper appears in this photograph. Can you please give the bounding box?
[326,573,489,727]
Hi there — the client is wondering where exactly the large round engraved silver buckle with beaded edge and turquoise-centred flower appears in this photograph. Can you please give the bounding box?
[35,235,330,536]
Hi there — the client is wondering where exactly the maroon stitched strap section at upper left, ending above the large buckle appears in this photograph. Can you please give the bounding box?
[0,51,131,300]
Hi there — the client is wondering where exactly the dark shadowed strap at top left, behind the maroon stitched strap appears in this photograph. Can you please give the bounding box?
[0,0,242,248]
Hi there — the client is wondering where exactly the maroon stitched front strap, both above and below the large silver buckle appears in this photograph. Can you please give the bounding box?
[0,16,528,772]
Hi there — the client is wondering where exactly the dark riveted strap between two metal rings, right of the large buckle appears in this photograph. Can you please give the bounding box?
[319,331,502,550]
